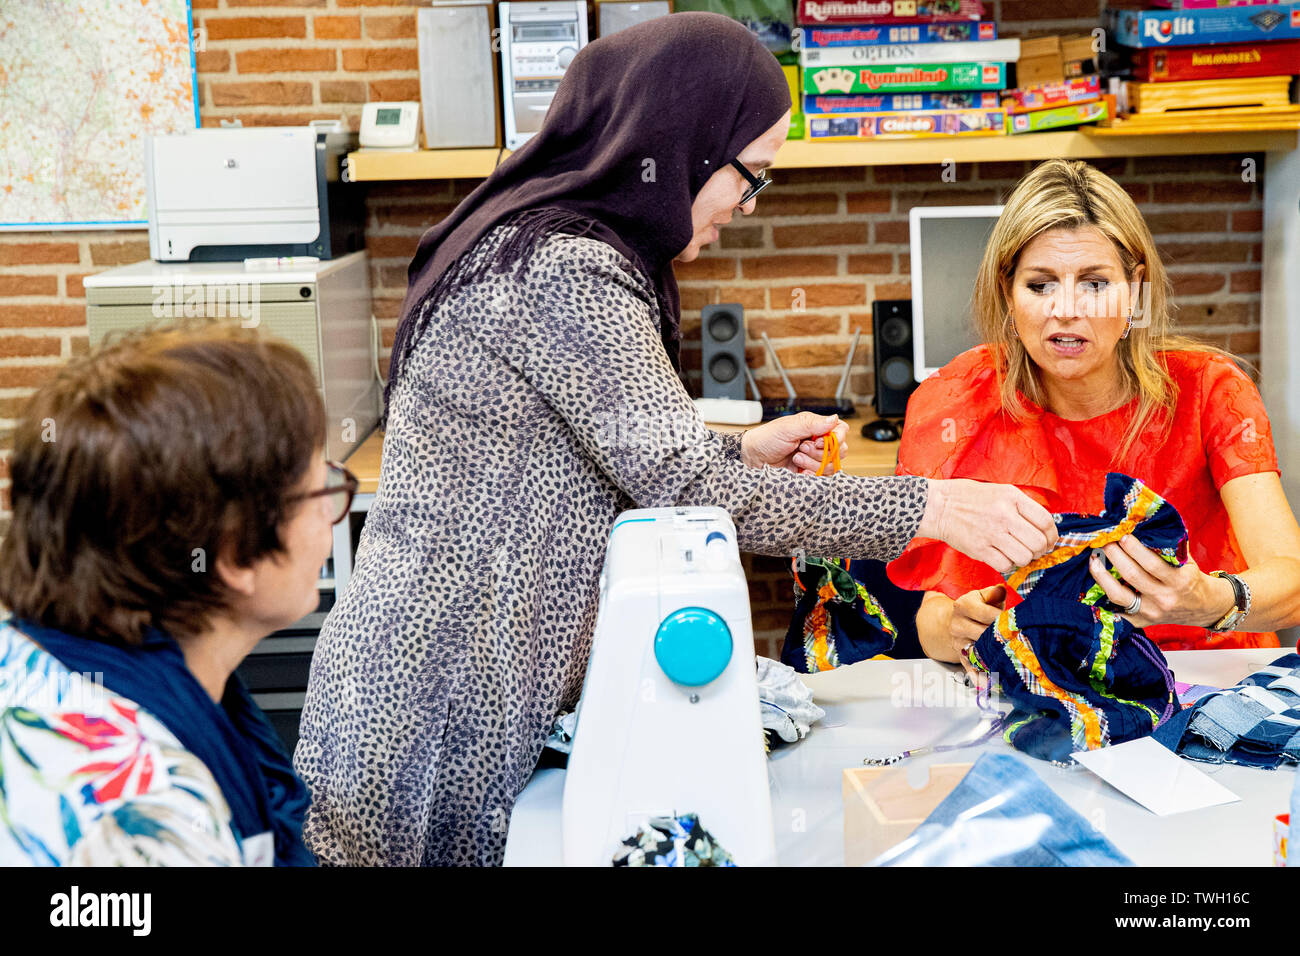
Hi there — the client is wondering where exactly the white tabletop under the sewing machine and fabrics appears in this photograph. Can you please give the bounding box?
[506,648,1295,866]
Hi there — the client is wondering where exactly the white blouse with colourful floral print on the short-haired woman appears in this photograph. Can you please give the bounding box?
[0,623,244,866]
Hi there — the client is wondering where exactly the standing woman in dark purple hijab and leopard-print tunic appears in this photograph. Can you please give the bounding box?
[295,13,1056,865]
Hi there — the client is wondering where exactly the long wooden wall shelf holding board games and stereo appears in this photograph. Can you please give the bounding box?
[348,127,1300,182]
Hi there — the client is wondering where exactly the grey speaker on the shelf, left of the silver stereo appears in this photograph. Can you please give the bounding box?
[416,0,501,150]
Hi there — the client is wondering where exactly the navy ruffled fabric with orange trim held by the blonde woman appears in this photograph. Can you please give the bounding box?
[967,473,1187,763]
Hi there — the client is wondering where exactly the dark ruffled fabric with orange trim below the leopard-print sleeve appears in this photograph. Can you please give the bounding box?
[781,557,898,674]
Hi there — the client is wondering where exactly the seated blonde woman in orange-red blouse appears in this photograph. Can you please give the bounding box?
[889,160,1300,661]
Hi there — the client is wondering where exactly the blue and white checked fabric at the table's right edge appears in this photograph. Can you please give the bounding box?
[1154,654,1300,770]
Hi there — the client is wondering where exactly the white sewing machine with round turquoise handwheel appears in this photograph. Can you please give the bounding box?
[506,507,776,866]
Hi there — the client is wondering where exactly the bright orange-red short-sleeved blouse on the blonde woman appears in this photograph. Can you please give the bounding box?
[889,346,1278,650]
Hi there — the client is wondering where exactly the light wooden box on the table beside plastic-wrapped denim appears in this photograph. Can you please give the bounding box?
[842,763,971,866]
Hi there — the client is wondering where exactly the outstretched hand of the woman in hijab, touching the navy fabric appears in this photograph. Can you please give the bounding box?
[917,479,1057,574]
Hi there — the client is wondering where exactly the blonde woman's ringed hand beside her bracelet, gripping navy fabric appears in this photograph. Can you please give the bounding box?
[1088,535,1236,627]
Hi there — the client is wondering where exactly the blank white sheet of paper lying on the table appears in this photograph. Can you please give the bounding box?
[1074,737,1242,817]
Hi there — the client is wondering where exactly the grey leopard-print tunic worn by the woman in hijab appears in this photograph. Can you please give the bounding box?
[294,226,927,865]
